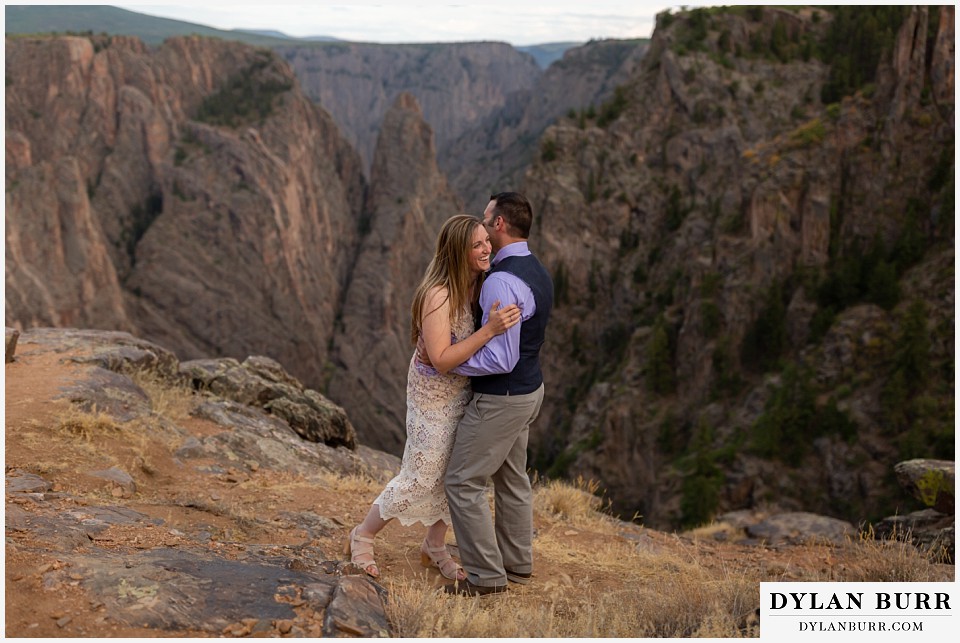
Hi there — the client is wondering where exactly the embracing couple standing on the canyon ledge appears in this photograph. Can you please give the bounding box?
[344,192,553,596]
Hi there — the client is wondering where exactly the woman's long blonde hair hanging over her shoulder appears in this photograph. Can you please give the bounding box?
[410,214,483,344]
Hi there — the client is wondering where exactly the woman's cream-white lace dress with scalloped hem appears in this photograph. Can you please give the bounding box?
[373,311,474,527]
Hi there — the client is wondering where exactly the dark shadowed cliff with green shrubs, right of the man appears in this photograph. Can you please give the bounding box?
[524,8,953,525]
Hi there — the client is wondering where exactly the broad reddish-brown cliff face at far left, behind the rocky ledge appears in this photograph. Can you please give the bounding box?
[6,37,365,394]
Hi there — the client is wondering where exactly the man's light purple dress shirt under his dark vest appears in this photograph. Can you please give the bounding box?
[450,241,537,376]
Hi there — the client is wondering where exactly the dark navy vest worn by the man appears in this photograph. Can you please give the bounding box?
[470,255,553,395]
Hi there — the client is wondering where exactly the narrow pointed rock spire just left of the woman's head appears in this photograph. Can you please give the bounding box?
[329,93,460,453]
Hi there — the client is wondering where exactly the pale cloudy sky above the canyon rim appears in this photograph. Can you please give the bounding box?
[109,0,716,46]
